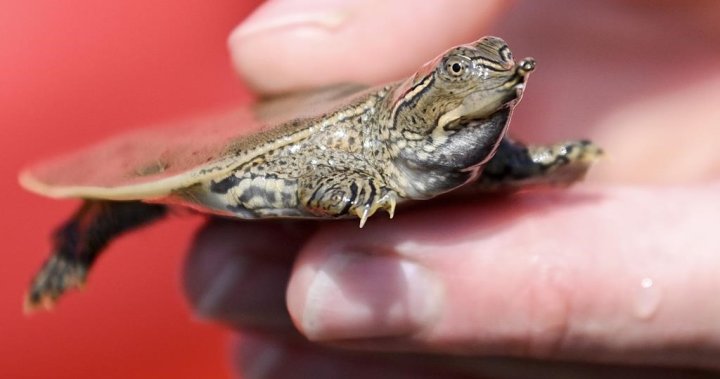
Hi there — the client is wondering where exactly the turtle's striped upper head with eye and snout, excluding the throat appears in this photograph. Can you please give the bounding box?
[393,37,535,132]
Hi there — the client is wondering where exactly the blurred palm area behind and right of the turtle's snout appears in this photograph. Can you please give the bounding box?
[493,2,720,184]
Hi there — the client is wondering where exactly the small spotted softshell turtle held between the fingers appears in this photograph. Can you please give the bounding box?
[20,37,601,310]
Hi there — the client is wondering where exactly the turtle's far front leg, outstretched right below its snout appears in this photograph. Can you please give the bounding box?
[473,138,603,191]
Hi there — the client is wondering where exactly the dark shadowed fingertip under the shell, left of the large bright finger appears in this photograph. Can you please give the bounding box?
[183,220,312,330]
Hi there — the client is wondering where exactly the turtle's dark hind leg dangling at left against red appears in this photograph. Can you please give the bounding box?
[25,200,167,312]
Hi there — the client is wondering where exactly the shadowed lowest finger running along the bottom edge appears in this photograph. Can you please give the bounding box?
[233,334,714,379]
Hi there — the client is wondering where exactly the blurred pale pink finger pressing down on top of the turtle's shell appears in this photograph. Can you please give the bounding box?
[229,0,507,93]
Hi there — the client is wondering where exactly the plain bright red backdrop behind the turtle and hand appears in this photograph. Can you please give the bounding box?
[0,0,262,378]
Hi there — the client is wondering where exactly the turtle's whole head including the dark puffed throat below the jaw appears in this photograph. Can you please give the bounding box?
[389,37,535,199]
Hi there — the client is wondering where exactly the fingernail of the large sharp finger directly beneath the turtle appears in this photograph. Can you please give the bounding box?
[301,253,443,340]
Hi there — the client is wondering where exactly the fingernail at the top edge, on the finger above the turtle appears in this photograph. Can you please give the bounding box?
[231,0,351,38]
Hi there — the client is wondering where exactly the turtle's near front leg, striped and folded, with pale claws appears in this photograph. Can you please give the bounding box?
[298,163,397,228]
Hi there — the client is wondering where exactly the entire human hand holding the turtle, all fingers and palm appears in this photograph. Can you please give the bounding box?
[185,0,720,377]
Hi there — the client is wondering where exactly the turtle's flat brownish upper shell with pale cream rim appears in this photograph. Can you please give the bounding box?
[19,85,362,201]
